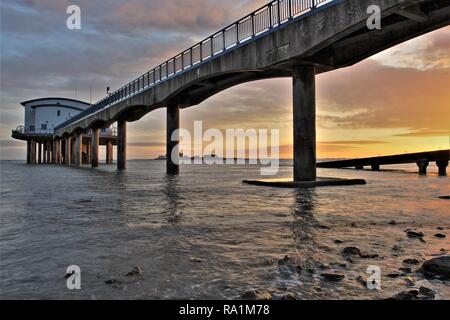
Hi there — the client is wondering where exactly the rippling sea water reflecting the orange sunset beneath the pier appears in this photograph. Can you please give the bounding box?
[0,161,450,299]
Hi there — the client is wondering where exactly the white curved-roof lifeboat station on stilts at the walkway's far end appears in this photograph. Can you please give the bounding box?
[12,98,117,166]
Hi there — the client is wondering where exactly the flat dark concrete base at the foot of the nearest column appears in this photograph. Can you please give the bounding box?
[243,177,366,188]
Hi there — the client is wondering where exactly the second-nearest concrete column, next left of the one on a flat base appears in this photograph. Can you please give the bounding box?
[166,105,180,174]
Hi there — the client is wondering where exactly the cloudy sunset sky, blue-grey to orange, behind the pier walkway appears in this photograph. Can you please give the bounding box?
[0,0,450,159]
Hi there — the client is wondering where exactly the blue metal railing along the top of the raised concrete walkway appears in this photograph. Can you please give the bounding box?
[55,0,336,130]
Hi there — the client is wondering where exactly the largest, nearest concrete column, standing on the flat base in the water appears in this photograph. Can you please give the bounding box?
[292,65,317,181]
